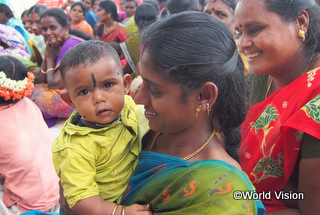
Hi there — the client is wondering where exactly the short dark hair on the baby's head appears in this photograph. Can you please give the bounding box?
[60,40,122,80]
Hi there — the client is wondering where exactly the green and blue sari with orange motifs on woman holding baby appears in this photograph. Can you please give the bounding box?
[122,151,265,214]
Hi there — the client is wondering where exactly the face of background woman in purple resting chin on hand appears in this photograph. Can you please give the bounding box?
[41,16,69,46]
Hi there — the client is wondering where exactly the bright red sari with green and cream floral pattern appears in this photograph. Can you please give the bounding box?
[240,68,320,212]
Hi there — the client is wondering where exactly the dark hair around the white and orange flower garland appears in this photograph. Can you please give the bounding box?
[0,55,28,105]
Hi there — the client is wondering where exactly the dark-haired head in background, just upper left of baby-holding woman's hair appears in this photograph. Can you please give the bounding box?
[134,3,158,31]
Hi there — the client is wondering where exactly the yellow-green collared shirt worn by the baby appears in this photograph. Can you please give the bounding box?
[52,96,145,208]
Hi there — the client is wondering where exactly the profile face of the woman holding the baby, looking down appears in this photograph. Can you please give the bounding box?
[135,51,197,133]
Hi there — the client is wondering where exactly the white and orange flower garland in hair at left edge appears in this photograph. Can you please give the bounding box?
[0,71,34,101]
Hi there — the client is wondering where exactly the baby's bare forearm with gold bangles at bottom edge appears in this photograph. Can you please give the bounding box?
[72,196,152,215]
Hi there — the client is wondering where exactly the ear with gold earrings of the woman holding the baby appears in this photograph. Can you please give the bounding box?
[199,81,218,110]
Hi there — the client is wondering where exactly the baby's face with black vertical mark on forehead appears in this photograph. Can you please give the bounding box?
[65,58,130,124]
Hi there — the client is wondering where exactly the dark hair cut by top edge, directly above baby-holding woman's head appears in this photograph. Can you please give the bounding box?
[167,0,199,14]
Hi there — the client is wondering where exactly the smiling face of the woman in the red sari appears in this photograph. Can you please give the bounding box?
[235,0,302,77]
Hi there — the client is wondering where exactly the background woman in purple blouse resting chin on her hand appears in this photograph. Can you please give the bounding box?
[31,8,83,127]
